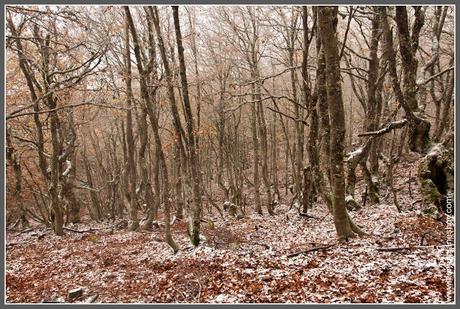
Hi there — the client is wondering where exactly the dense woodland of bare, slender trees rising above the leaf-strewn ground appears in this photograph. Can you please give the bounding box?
[6,5,455,243]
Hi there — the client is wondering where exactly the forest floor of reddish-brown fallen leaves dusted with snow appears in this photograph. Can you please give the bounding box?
[6,156,454,303]
